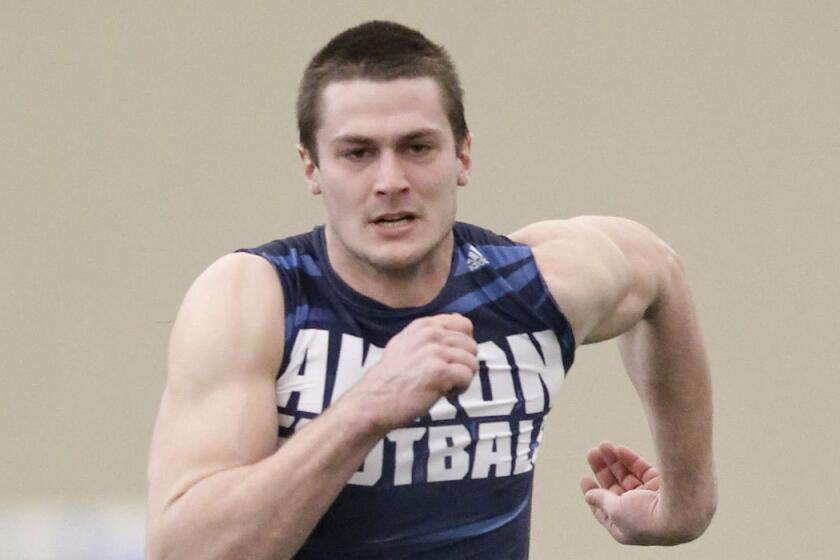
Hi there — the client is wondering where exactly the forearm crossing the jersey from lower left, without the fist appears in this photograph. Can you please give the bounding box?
[148,394,384,559]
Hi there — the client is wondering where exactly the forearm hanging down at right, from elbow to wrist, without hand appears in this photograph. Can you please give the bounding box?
[619,260,717,538]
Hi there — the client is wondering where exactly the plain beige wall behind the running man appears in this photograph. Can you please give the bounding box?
[0,0,840,559]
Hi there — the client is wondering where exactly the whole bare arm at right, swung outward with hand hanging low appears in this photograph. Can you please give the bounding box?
[512,217,716,544]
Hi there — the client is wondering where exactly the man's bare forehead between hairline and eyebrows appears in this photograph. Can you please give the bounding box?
[316,77,450,142]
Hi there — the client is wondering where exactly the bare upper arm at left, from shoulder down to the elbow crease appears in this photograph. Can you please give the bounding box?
[148,255,283,512]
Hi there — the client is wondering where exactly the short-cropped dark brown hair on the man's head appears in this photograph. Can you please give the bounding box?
[297,21,468,165]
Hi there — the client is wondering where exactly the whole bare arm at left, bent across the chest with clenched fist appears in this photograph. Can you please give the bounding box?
[147,254,478,559]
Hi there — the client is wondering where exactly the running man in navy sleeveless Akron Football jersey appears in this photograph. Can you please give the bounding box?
[148,22,716,559]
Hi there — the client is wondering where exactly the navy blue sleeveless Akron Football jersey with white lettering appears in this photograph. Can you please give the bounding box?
[244,223,575,560]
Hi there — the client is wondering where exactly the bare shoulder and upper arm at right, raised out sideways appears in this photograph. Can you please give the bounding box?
[510,216,673,342]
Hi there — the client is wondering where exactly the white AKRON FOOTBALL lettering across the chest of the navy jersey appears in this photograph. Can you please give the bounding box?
[277,329,565,486]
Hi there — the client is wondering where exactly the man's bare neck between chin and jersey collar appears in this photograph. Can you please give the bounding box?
[325,227,455,308]
